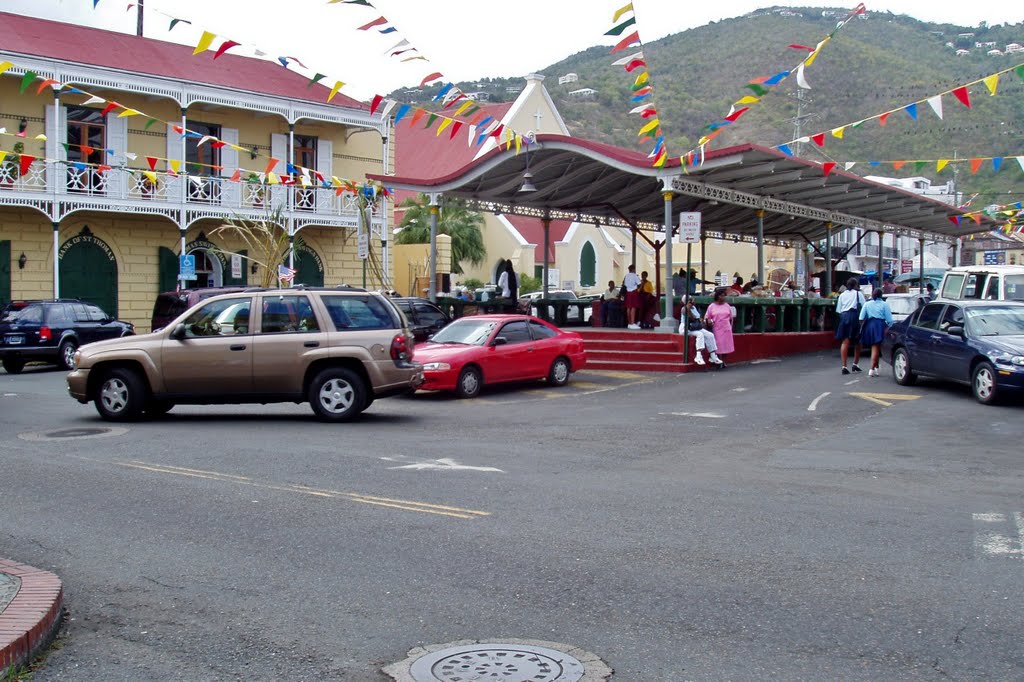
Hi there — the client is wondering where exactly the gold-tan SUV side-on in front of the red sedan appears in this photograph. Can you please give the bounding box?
[68,287,423,422]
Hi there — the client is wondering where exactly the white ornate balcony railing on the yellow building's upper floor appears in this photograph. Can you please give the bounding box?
[0,157,376,218]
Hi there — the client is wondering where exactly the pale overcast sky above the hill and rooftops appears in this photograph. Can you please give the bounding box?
[0,0,1024,99]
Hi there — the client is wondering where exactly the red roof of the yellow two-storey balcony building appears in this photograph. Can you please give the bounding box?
[0,12,368,110]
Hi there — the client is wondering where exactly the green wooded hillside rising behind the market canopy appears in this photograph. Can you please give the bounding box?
[395,8,1024,204]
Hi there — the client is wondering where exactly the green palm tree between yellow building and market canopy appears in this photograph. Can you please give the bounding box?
[395,195,487,274]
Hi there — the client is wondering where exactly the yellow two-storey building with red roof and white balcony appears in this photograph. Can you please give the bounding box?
[0,12,390,331]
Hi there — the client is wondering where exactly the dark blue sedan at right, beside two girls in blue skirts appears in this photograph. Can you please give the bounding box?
[882,300,1024,404]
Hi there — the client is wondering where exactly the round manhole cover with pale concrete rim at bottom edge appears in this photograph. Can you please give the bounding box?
[384,640,611,682]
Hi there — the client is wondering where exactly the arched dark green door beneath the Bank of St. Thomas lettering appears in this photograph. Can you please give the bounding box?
[58,228,118,317]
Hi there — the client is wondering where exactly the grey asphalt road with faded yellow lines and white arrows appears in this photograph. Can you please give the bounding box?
[0,353,1024,682]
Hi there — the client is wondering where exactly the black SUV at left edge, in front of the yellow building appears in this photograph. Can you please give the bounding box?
[0,299,135,374]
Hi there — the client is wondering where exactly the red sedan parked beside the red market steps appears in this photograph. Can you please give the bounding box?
[413,315,587,397]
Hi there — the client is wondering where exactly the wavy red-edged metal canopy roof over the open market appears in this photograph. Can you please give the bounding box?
[370,134,996,244]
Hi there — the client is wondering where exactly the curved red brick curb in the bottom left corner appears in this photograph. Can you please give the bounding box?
[0,559,63,675]
